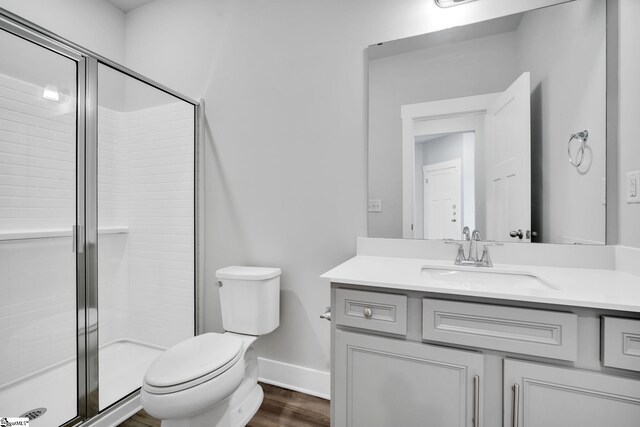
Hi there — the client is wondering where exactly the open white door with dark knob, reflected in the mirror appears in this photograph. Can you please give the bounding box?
[486,72,531,242]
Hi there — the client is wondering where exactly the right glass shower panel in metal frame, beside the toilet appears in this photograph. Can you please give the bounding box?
[97,63,195,411]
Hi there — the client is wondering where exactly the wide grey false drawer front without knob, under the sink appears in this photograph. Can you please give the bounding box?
[422,298,578,361]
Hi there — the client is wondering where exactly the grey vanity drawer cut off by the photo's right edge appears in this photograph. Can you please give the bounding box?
[602,316,640,371]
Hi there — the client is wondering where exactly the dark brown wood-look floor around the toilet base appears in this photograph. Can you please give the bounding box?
[119,383,330,427]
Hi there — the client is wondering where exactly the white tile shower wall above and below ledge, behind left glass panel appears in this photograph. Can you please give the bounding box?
[0,75,76,387]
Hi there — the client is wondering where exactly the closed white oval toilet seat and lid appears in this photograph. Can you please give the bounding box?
[143,333,243,394]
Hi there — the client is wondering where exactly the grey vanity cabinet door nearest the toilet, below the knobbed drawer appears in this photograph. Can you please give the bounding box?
[331,330,483,427]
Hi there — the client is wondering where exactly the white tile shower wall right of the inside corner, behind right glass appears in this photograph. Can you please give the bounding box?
[127,103,194,346]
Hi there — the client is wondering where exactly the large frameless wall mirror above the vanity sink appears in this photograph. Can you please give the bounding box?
[368,0,607,244]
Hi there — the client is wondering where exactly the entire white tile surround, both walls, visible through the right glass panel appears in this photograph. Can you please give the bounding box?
[98,104,193,347]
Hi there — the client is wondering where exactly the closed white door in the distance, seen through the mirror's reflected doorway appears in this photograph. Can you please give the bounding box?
[422,159,462,239]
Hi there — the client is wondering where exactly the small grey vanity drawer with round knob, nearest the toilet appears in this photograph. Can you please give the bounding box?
[335,289,407,335]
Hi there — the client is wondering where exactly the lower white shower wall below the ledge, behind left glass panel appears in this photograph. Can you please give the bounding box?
[0,237,76,389]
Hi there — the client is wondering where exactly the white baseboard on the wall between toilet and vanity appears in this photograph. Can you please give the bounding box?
[258,357,331,400]
